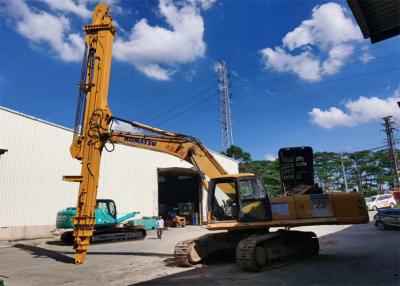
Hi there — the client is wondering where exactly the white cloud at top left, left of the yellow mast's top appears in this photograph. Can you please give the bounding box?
[4,0,84,62]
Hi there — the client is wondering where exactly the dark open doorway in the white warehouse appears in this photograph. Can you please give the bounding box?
[158,168,202,225]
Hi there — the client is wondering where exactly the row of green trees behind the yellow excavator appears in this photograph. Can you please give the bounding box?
[225,146,400,196]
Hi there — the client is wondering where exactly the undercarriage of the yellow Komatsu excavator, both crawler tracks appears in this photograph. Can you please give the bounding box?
[174,229,319,271]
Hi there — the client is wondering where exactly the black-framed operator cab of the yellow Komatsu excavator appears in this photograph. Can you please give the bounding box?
[209,174,272,222]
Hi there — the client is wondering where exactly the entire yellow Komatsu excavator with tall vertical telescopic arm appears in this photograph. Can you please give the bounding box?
[64,3,368,271]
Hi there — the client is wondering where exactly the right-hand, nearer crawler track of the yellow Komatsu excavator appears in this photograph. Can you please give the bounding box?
[236,231,319,272]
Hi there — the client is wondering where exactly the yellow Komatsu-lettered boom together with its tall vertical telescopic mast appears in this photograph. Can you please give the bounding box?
[63,3,227,264]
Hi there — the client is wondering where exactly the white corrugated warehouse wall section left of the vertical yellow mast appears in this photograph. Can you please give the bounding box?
[0,109,80,227]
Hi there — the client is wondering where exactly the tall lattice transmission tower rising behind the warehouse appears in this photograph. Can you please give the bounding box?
[218,60,233,151]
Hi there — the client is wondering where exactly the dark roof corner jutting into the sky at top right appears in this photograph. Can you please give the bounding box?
[347,0,400,43]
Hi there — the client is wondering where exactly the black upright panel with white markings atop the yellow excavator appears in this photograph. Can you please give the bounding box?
[278,147,314,190]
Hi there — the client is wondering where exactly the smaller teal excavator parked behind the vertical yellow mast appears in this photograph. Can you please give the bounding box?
[56,199,146,244]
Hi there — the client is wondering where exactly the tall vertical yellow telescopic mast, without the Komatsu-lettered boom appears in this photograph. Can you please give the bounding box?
[64,3,115,264]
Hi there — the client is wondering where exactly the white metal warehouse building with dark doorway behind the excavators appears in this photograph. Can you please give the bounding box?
[0,107,238,240]
